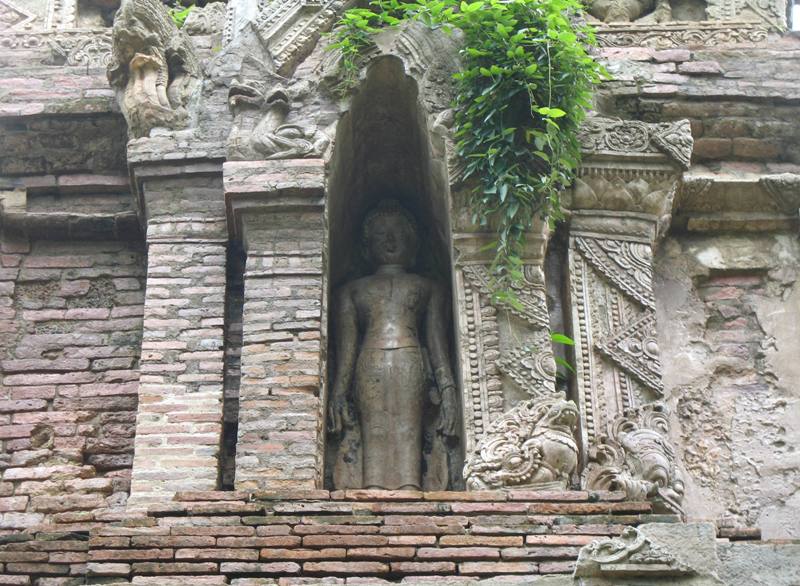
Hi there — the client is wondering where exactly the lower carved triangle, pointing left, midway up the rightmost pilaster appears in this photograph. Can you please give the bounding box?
[595,311,664,395]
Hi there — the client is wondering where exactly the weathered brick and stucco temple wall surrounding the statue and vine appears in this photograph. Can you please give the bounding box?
[0,0,800,586]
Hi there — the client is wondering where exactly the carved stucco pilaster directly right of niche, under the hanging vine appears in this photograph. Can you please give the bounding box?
[455,226,577,490]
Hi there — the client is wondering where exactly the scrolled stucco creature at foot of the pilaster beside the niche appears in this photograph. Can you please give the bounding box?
[464,394,578,490]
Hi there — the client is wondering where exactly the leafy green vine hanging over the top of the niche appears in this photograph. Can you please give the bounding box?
[330,0,605,292]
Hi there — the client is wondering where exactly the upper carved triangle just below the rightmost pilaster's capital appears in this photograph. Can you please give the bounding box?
[575,236,655,310]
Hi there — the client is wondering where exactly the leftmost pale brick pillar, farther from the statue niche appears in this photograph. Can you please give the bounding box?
[130,165,227,505]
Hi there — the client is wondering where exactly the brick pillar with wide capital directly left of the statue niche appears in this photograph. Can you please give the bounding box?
[224,159,326,490]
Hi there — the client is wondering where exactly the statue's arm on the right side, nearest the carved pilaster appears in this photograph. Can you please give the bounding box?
[425,283,458,437]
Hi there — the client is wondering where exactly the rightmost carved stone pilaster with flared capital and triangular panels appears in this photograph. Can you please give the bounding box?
[568,119,692,511]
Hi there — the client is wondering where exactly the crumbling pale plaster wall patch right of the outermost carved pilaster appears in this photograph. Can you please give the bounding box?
[655,233,800,538]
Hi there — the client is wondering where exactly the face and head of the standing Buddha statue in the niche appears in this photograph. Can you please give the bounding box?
[364,204,417,269]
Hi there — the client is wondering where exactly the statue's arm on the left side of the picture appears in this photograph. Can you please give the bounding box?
[328,288,358,434]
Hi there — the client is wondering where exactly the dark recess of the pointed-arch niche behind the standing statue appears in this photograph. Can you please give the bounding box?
[325,56,463,490]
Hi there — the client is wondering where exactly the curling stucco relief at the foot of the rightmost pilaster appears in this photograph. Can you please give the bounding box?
[584,402,684,513]
